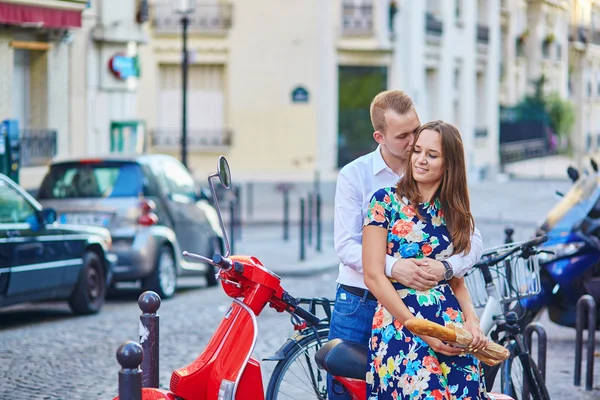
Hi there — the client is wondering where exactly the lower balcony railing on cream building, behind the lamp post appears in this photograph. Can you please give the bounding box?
[152,129,233,150]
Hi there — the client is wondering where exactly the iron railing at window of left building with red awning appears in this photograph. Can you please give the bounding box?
[19,129,57,167]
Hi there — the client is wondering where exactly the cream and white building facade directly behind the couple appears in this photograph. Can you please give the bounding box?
[138,0,501,179]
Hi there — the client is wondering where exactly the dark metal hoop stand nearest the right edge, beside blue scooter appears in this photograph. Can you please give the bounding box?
[573,294,596,390]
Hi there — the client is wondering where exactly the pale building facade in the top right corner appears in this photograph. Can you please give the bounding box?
[500,0,600,167]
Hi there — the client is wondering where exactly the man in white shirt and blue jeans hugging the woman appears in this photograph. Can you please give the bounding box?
[327,90,483,400]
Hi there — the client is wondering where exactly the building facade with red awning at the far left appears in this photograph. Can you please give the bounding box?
[0,0,86,184]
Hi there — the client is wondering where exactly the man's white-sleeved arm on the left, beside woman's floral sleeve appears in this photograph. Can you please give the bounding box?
[333,169,365,274]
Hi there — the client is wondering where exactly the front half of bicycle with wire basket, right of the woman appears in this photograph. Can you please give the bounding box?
[465,236,550,400]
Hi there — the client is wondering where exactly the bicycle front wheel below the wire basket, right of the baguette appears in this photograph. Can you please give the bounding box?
[501,346,550,400]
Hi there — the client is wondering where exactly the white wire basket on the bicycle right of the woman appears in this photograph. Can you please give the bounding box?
[465,242,540,308]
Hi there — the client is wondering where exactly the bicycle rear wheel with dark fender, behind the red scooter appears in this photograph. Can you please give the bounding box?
[266,327,329,400]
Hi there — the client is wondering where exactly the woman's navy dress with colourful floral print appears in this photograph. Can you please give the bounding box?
[364,188,487,400]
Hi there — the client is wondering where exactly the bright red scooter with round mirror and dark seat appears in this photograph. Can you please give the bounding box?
[114,157,511,400]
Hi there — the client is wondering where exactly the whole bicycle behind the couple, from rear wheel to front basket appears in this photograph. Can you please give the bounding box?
[267,237,550,400]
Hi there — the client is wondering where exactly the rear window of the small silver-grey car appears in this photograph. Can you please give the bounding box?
[38,162,144,199]
